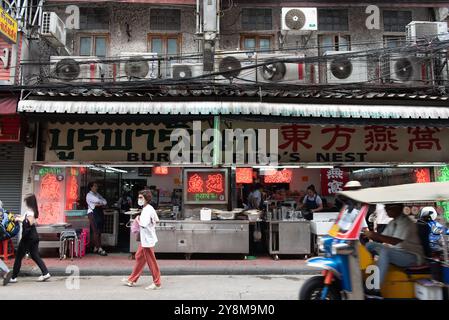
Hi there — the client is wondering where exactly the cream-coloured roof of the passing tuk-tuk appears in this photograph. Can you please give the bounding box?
[338,182,449,204]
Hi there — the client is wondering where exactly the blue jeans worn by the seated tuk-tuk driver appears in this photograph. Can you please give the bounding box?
[366,242,418,285]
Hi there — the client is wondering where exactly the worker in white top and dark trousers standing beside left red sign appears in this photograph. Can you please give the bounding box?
[86,182,107,256]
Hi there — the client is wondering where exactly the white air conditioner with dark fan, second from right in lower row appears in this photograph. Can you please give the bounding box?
[324,51,368,84]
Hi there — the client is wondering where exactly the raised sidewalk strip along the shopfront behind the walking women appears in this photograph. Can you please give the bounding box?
[2,253,319,276]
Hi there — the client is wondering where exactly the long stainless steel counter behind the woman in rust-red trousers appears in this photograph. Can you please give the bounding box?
[131,219,249,254]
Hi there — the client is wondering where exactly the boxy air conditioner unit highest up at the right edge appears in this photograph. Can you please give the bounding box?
[406,21,449,43]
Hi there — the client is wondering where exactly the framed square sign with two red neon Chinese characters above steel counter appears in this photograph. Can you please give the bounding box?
[184,169,228,204]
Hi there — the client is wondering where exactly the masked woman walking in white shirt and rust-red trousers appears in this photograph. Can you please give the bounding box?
[125,190,161,290]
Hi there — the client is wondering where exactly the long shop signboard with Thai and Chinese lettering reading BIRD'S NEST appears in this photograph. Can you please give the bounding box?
[43,121,449,165]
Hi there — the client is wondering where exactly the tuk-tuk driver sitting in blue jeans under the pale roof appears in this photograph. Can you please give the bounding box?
[363,204,425,296]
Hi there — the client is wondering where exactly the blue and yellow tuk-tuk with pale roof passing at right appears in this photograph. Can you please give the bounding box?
[299,182,449,300]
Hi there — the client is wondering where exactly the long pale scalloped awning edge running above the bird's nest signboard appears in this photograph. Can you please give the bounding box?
[18,100,449,119]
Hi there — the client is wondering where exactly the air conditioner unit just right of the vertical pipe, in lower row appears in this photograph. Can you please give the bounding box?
[215,52,256,84]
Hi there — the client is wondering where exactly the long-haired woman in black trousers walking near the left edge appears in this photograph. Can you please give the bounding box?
[10,194,50,283]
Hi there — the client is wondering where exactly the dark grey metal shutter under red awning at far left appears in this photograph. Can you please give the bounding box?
[0,143,24,214]
